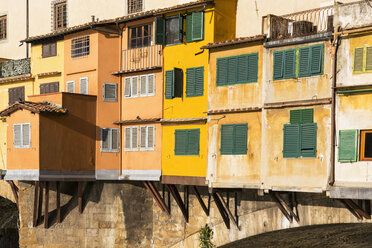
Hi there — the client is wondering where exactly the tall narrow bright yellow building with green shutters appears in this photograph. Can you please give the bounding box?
[161,0,236,185]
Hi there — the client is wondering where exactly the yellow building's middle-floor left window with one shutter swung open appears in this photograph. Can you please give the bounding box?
[165,68,183,99]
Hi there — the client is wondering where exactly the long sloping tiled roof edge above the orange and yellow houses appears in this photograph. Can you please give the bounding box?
[21,0,214,43]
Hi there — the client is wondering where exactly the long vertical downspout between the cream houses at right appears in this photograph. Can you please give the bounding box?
[329,26,339,186]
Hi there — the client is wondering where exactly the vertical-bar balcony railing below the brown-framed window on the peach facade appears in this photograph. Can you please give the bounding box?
[121,45,163,71]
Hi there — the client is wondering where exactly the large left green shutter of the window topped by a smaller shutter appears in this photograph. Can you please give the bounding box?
[283,124,300,158]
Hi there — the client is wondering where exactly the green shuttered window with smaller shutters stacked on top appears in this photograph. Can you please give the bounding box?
[283,109,317,158]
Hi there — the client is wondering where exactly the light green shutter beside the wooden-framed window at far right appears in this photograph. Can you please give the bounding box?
[338,130,358,162]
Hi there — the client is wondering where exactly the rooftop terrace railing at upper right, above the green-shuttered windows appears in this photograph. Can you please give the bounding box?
[263,6,334,40]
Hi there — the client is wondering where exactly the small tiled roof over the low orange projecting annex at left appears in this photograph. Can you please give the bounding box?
[0,101,67,117]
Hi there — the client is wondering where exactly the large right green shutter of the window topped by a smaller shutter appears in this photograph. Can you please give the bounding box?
[300,123,317,158]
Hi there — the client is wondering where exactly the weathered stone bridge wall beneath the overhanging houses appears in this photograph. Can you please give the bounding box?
[0,181,371,248]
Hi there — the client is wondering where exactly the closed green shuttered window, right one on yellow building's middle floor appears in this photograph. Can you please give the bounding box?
[186,66,204,97]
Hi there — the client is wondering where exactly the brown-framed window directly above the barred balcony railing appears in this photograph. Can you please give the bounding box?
[128,24,152,48]
